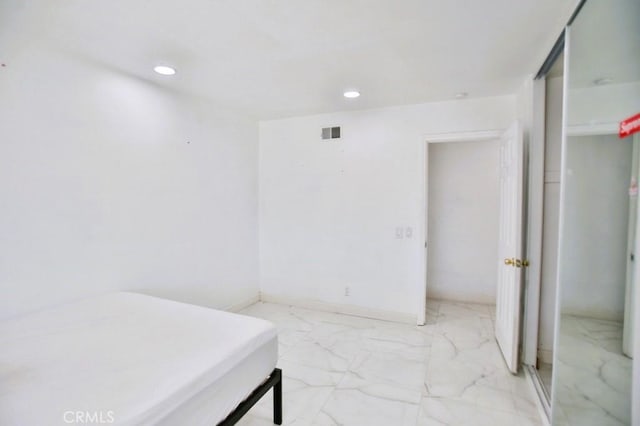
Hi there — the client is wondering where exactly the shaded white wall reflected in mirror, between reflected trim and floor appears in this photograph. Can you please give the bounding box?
[560,135,632,321]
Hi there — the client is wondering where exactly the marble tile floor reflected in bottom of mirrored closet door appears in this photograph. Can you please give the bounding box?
[553,315,632,426]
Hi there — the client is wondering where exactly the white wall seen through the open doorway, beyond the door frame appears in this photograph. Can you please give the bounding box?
[427,140,500,303]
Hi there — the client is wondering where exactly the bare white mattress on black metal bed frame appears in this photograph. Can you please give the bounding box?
[0,293,277,426]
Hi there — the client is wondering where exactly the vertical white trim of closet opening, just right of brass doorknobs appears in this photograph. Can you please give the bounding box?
[522,79,546,365]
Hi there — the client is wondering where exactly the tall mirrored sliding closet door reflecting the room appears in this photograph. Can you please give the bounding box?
[552,0,640,426]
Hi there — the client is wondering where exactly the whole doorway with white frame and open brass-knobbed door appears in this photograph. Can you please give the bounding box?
[418,126,529,374]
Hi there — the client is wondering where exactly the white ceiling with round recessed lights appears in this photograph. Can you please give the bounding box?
[0,0,577,119]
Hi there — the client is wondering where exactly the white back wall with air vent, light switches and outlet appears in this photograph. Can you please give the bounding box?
[259,96,516,318]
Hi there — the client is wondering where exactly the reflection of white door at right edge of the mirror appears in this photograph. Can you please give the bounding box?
[622,135,640,358]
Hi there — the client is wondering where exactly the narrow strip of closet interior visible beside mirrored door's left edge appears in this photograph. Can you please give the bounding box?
[538,77,563,362]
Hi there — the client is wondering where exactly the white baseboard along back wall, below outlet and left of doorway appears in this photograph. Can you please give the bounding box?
[260,292,417,325]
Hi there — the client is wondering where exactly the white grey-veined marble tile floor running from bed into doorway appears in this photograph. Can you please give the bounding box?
[239,301,542,426]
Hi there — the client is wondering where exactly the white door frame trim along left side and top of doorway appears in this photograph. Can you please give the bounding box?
[417,129,504,325]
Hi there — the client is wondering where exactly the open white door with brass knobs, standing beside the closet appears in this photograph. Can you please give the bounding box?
[495,122,524,373]
